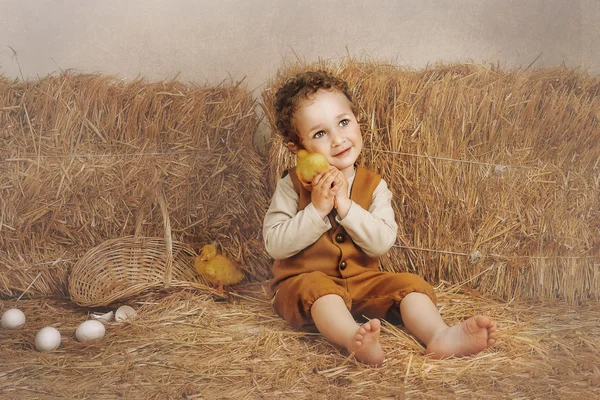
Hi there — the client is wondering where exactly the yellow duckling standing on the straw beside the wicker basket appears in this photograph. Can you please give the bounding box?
[194,244,244,294]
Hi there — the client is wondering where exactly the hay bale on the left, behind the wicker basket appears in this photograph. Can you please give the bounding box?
[0,72,268,296]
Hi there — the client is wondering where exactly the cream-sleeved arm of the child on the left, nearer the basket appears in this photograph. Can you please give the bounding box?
[263,176,331,260]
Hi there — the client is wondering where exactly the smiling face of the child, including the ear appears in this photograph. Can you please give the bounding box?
[288,89,362,177]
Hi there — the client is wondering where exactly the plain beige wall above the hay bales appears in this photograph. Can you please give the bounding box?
[0,0,600,93]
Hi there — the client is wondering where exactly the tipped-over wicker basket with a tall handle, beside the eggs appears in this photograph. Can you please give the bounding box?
[68,188,206,307]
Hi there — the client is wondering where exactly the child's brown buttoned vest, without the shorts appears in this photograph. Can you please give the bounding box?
[272,167,381,289]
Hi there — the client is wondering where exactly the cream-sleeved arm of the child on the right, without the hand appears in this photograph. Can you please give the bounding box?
[338,179,398,257]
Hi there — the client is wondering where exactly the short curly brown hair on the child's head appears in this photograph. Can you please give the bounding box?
[273,71,357,145]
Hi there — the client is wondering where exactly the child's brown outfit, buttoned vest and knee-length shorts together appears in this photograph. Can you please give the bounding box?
[271,167,436,331]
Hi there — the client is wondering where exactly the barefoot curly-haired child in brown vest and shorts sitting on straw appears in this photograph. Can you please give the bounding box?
[263,71,496,365]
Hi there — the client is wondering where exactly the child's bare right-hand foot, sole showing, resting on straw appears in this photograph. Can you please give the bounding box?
[426,315,496,358]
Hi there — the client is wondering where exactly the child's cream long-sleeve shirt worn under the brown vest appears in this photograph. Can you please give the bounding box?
[263,168,398,260]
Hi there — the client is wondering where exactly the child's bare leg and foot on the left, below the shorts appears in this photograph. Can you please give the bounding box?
[310,294,383,365]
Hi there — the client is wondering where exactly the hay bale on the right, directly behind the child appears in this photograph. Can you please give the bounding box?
[262,60,600,302]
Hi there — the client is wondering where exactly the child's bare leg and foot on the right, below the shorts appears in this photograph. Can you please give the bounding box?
[400,292,496,358]
